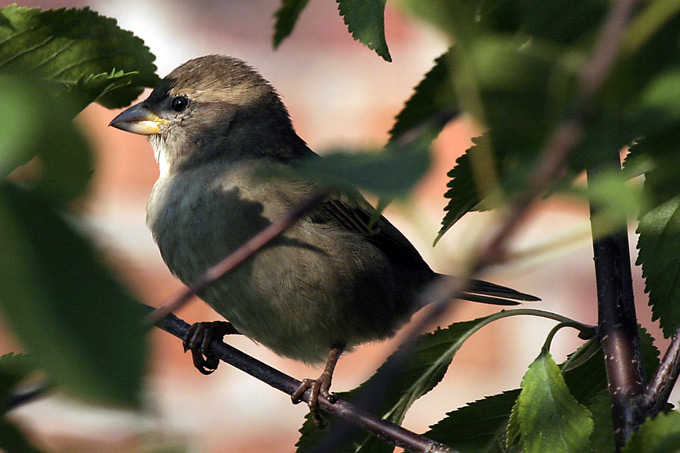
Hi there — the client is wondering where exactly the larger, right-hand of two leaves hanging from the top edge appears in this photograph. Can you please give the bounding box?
[337,0,392,61]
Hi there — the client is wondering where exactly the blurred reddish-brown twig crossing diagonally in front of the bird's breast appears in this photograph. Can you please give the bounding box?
[147,192,326,324]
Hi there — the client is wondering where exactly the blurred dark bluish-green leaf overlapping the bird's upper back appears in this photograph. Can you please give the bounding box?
[296,142,431,199]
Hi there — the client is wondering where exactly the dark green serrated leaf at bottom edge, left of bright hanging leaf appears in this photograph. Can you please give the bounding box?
[423,390,519,453]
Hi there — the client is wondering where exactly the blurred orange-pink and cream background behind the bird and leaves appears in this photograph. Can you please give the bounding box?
[0,0,675,452]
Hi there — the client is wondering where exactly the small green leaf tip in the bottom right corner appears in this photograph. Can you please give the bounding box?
[622,411,680,453]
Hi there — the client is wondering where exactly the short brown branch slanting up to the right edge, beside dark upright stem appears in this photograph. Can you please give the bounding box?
[640,327,680,417]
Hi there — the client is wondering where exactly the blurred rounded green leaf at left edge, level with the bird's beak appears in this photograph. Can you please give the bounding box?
[0,76,93,202]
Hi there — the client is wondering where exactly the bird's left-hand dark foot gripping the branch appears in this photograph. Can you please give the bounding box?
[182,321,239,374]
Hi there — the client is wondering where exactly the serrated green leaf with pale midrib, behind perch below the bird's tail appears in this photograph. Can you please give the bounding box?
[296,316,490,453]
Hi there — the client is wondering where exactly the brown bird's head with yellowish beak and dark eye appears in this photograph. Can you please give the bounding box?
[109,55,304,171]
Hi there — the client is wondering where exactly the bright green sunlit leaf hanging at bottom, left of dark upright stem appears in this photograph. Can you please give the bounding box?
[517,351,593,453]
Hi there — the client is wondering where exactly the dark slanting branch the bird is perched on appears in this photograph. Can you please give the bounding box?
[156,314,455,453]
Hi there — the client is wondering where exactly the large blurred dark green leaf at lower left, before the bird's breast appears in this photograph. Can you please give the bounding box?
[0,184,147,406]
